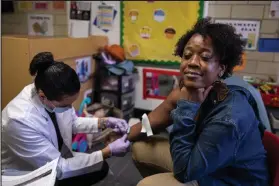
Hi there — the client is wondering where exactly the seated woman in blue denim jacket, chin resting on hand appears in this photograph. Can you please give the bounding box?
[128,19,269,186]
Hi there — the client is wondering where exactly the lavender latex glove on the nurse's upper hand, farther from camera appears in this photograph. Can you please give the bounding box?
[106,117,129,134]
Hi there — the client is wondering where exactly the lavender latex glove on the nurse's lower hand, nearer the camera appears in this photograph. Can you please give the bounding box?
[108,134,130,157]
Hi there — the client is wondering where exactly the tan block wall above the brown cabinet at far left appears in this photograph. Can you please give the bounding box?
[1,1,68,36]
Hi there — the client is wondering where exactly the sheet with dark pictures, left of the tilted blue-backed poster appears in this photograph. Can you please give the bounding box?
[70,1,91,21]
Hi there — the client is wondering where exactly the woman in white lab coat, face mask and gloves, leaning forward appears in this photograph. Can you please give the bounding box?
[1,52,130,185]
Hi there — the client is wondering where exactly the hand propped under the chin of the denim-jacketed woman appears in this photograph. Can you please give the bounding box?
[180,86,212,103]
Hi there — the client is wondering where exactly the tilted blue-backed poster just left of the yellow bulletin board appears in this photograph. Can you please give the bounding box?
[93,4,117,32]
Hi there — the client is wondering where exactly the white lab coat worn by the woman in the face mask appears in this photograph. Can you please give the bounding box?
[1,84,103,179]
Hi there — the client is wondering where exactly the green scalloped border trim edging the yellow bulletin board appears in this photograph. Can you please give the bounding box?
[120,0,204,67]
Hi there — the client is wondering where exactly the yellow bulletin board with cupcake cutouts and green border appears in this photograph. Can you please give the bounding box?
[121,0,204,65]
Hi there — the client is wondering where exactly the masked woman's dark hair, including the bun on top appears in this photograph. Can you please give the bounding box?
[29,52,80,101]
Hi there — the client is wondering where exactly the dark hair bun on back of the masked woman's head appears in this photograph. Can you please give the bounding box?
[29,52,54,76]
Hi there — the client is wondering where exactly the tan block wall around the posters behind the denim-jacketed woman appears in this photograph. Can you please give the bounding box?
[208,1,279,80]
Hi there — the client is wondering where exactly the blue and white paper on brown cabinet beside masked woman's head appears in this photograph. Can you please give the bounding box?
[76,57,92,83]
